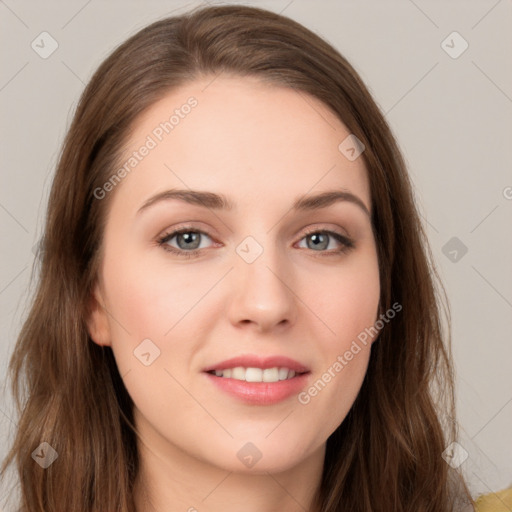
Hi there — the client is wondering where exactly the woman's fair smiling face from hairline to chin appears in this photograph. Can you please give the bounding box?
[88,75,380,472]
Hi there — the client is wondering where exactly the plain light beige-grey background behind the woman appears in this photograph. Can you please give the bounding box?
[0,0,512,510]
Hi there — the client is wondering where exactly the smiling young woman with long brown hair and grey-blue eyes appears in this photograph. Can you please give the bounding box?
[3,6,473,512]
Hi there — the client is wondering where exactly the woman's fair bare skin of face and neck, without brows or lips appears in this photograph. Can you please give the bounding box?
[88,75,380,512]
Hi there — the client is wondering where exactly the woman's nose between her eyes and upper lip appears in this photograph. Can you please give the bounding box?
[228,242,300,333]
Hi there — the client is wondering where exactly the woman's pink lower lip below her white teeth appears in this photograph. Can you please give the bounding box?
[205,373,309,405]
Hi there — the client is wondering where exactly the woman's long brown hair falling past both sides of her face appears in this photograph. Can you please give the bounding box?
[2,6,472,512]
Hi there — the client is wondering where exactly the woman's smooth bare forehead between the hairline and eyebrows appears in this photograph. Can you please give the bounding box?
[112,74,371,210]
